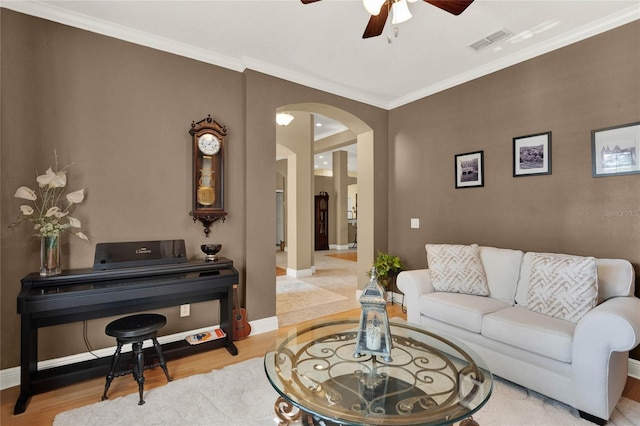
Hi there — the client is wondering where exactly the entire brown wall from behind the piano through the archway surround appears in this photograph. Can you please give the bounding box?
[0,9,388,368]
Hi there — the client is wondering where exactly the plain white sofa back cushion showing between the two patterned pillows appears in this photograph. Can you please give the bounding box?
[478,246,524,305]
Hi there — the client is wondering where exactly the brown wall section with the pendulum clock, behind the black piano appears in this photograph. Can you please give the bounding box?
[0,5,245,368]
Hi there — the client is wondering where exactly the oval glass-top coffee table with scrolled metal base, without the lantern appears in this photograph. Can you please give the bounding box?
[264,319,493,426]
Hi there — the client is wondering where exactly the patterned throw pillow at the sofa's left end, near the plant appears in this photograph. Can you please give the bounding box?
[425,244,489,296]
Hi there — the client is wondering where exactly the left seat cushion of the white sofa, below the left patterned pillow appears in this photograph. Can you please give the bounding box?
[420,292,510,333]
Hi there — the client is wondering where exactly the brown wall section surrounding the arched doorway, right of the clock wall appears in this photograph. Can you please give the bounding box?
[244,70,388,319]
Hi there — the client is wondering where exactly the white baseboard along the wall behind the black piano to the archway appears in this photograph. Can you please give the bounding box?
[0,316,278,390]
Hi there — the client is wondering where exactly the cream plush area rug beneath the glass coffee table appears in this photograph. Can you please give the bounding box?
[53,358,640,426]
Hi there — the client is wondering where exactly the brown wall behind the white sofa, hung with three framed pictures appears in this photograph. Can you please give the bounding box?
[389,21,640,358]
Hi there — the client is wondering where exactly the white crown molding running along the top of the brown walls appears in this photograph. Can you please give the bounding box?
[0,0,640,110]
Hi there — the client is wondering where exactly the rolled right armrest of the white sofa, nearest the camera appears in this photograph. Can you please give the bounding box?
[572,296,640,419]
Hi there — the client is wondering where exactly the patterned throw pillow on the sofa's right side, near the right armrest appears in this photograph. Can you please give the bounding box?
[527,253,598,323]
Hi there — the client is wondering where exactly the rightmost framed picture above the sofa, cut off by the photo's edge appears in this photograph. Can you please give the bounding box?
[591,122,640,177]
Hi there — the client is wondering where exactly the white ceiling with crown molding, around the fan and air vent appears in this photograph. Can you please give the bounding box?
[0,0,640,175]
